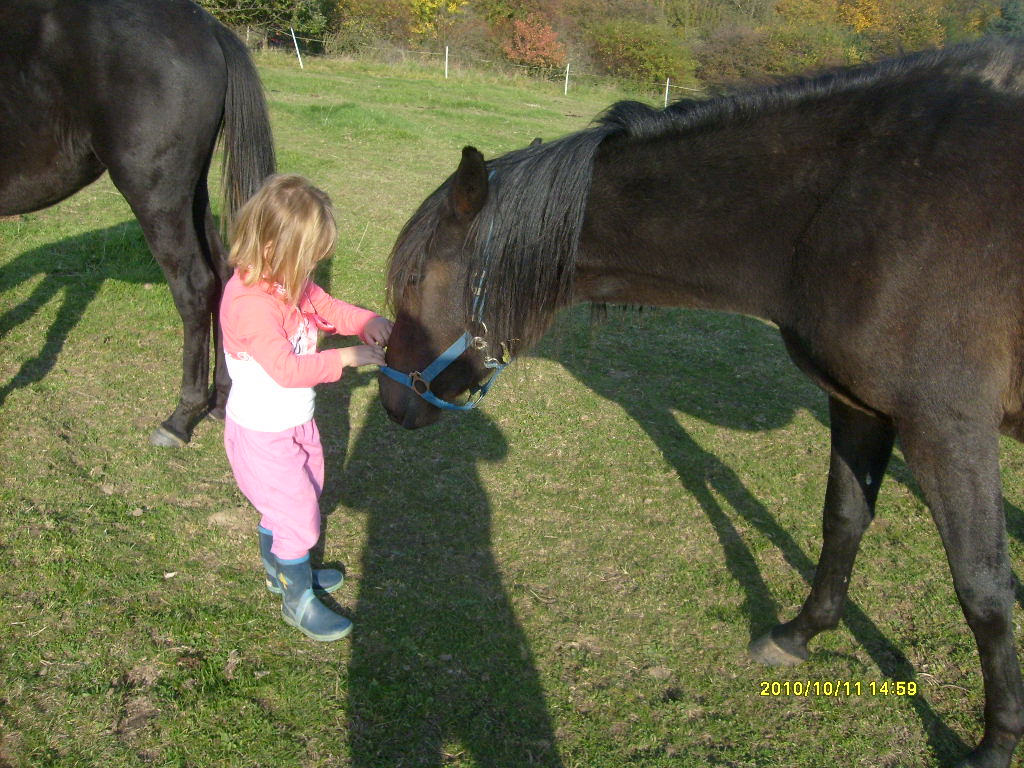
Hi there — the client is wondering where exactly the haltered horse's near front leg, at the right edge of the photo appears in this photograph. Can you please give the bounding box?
[899,418,1024,768]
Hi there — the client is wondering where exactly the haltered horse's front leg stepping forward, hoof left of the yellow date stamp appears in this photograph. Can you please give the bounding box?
[749,397,894,666]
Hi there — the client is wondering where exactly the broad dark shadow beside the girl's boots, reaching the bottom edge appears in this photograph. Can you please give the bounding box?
[317,372,562,768]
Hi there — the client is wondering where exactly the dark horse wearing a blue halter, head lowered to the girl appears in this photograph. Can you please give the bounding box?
[380,41,1024,768]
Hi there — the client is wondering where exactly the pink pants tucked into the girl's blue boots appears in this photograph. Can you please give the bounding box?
[224,418,324,560]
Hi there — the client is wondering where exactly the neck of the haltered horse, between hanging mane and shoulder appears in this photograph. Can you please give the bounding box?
[574,116,843,322]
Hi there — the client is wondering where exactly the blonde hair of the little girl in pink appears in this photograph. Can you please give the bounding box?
[228,174,338,304]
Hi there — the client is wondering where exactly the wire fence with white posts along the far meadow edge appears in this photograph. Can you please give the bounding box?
[244,28,703,105]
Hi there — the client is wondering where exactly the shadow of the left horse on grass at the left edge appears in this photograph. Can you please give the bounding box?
[0,219,164,408]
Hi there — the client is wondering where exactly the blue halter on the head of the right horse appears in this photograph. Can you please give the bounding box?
[380,204,512,411]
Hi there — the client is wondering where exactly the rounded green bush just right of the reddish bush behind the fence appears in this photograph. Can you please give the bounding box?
[587,20,694,84]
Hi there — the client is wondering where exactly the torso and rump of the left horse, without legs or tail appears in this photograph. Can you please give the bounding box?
[0,0,225,213]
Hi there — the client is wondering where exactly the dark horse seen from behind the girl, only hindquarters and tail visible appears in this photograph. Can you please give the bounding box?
[0,0,274,445]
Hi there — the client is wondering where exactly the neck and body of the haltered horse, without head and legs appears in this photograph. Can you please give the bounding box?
[578,41,1024,434]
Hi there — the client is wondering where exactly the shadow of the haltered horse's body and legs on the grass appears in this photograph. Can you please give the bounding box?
[536,309,991,761]
